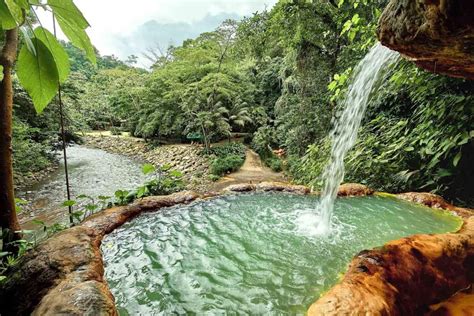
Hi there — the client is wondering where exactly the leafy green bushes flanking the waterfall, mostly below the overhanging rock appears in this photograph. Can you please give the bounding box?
[290,62,474,203]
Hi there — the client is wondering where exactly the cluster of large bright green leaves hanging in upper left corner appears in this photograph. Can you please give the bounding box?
[0,0,96,113]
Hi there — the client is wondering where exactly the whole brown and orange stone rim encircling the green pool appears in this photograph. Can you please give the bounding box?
[0,182,474,315]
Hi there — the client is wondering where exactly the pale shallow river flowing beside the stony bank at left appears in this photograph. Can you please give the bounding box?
[17,146,145,229]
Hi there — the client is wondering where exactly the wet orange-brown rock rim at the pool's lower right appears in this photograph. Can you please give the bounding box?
[308,193,474,315]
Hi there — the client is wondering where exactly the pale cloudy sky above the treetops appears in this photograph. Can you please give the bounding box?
[38,0,277,66]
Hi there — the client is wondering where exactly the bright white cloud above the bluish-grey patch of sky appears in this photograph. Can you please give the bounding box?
[38,0,277,61]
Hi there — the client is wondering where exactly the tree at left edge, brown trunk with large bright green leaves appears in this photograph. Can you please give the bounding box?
[0,0,95,251]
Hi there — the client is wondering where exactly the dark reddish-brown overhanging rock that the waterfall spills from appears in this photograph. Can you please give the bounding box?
[377,0,474,80]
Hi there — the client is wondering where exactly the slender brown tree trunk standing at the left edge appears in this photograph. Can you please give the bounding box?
[0,28,21,251]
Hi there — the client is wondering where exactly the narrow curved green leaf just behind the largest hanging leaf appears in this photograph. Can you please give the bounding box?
[33,27,71,83]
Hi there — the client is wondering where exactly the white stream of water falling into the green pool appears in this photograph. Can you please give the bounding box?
[317,43,399,234]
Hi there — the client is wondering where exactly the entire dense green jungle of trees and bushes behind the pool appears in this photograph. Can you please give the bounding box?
[0,0,474,247]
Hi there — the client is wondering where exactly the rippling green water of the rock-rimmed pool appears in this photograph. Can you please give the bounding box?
[102,193,461,315]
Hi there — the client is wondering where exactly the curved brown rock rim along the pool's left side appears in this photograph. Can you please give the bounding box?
[0,192,199,315]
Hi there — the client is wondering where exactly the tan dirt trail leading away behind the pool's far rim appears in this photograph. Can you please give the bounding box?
[212,149,286,191]
